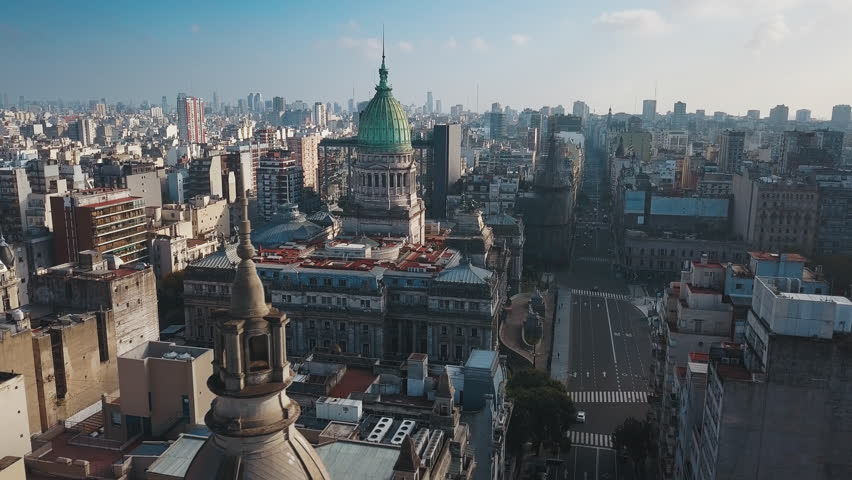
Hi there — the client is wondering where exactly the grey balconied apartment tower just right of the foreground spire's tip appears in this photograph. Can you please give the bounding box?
[257,149,304,221]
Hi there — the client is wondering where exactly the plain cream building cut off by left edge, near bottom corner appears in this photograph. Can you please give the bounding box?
[0,371,32,458]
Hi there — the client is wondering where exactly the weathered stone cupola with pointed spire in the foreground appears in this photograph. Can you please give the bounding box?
[185,196,329,480]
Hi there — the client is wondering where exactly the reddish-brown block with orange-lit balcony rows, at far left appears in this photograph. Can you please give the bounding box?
[50,189,148,263]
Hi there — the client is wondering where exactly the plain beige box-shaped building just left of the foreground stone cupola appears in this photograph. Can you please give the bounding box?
[104,342,214,441]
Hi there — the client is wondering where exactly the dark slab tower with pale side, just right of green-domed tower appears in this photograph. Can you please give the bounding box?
[429,123,461,218]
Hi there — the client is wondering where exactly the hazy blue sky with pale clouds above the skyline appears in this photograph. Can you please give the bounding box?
[0,0,852,117]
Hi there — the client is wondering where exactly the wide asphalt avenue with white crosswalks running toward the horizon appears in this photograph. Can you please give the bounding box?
[551,145,651,480]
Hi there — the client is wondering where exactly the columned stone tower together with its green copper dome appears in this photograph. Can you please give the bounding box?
[343,47,425,243]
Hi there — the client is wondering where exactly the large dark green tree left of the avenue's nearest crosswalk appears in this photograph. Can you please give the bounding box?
[506,369,576,455]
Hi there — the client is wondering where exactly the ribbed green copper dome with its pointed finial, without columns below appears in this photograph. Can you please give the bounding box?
[358,55,411,153]
